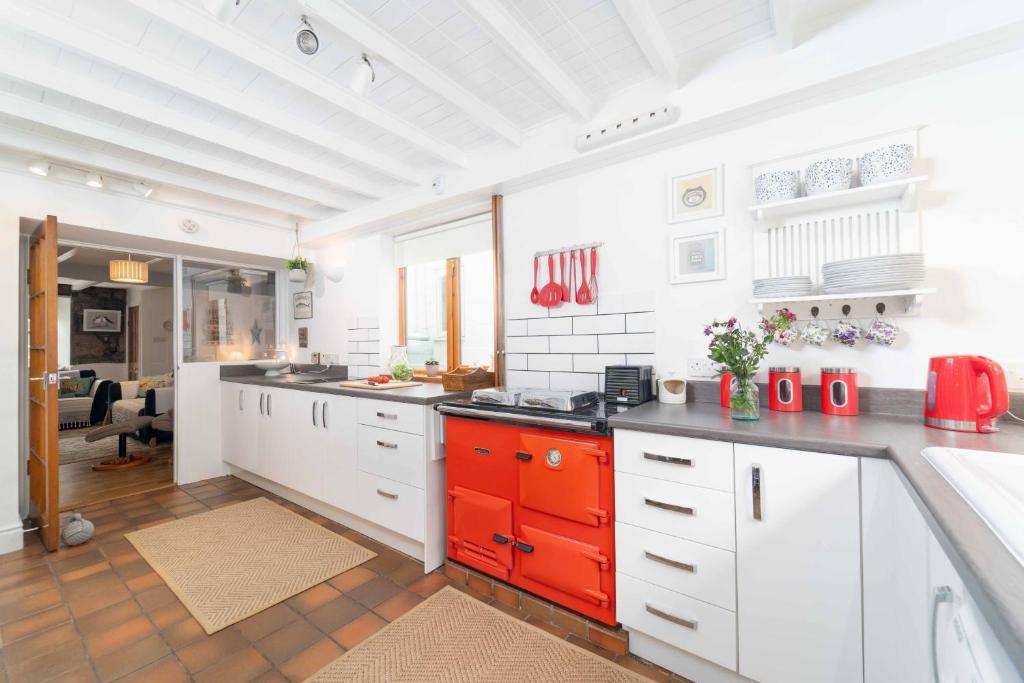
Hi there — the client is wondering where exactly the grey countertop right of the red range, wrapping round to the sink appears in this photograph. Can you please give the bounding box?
[608,401,1024,671]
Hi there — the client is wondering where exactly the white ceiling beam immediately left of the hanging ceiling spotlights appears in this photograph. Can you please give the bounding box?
[122,0,468,167]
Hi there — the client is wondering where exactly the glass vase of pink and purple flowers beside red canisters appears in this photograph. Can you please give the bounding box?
[703,308,797,420]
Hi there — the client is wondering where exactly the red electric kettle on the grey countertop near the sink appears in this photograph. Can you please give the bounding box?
[925,355,1010,432]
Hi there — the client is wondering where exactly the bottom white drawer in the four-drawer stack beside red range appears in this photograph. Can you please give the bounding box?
[615,571,736,671]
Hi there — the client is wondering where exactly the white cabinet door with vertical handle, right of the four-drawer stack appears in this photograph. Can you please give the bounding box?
[735,444,863,683]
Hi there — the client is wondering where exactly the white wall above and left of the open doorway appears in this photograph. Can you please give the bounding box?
[0,170,292,553]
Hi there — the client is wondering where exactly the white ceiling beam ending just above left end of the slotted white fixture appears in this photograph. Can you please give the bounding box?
[458,0,594,121]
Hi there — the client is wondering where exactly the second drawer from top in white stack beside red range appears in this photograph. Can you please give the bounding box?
[615,472,736,551]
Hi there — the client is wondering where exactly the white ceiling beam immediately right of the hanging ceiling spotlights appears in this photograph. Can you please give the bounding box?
[302,0,522,146]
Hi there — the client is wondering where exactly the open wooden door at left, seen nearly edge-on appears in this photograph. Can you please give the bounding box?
[29,216,60,550]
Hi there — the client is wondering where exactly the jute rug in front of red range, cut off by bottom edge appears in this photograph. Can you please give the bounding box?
[305,587,647,683]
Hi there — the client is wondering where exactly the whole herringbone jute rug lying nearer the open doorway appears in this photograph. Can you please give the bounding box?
[125,498,377,634]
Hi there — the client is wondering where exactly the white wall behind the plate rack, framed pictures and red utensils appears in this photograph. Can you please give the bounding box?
[505,52,1024,388]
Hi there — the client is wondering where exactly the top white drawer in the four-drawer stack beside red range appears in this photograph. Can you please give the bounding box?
[615,429,733,492]
